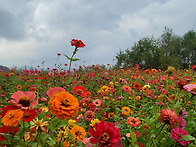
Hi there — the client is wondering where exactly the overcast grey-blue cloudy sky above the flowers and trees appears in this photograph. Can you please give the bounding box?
[0,0,196,68]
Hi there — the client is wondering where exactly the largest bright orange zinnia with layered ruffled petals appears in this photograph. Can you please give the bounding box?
[48,91,79,119]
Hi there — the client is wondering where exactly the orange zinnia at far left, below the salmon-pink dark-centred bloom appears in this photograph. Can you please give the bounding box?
[2,109,24,126]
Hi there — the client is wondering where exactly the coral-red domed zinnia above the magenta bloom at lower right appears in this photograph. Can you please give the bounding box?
[158,109,179,127]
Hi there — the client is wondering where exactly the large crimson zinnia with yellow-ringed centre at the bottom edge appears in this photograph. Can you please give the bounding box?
[89,120,121,147]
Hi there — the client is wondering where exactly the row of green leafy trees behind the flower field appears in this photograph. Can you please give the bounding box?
[115,27,196,69]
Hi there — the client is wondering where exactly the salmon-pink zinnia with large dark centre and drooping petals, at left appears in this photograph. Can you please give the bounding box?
[9,91,37,109]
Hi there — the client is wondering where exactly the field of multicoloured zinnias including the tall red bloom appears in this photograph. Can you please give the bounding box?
[0,39,196,147]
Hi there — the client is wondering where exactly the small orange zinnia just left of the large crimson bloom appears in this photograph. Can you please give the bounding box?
[70,125,86,141]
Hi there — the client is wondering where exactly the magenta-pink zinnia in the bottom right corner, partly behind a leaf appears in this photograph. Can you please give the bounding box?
[170,128,189,146]
